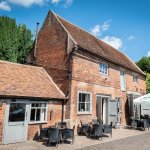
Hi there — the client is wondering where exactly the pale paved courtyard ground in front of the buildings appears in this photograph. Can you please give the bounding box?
[0,128,150,150]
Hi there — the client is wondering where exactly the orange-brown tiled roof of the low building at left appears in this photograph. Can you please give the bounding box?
[0,61,65,99]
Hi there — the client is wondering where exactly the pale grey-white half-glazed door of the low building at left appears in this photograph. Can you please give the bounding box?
[3,100,29,144]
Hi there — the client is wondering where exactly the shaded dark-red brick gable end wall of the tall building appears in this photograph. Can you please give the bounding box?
[31,12,72,94]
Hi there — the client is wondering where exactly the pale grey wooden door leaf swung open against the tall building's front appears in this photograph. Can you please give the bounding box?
[108,99,117,124]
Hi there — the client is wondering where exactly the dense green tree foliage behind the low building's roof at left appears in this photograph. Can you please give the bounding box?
[0,16,33,64]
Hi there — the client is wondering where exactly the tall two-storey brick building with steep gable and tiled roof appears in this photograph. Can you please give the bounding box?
[29,11,146,128]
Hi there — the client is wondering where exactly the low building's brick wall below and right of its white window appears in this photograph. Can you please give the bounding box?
[28,101,62,140]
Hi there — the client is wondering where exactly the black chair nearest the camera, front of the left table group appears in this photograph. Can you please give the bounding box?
[48,128,60,147]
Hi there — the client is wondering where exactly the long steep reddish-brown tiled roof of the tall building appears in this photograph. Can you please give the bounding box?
[54,14,145,75]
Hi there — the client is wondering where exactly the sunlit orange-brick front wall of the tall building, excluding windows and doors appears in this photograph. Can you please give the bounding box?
[68,55,146,125]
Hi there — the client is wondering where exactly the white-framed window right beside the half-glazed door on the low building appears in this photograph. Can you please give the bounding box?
[30,103,47,122]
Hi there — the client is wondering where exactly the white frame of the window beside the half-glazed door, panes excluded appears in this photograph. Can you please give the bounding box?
[29,101,48,124]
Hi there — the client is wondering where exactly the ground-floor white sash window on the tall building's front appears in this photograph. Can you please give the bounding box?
[78,92,91,113]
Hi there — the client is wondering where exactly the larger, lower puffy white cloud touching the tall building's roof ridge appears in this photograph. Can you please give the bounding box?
[101,36,123,49]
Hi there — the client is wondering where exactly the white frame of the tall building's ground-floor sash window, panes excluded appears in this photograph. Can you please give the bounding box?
[77,91,92,114]
